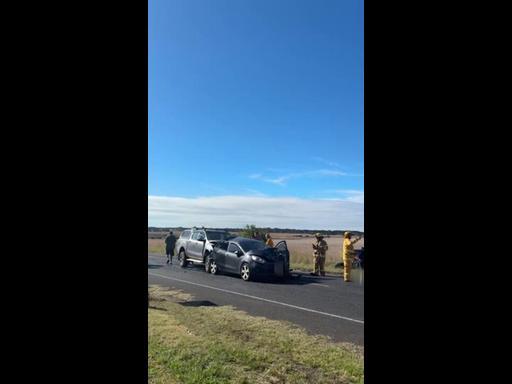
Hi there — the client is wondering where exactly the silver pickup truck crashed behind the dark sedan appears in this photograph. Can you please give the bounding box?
[174,228,234,268]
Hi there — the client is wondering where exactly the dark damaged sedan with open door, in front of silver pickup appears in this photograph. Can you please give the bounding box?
[205,237,290,281]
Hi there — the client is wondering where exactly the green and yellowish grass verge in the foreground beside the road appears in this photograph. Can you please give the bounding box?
[148,287,364,384]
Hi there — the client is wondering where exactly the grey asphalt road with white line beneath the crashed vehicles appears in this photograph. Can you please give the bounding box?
[148,255,364,345]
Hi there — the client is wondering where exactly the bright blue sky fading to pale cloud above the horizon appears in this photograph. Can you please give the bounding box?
[148,0,364,229]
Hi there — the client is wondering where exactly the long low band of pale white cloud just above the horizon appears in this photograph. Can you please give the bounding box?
[148,196,364,230]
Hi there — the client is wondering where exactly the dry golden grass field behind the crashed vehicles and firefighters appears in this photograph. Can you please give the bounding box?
[148,232,364,272]
